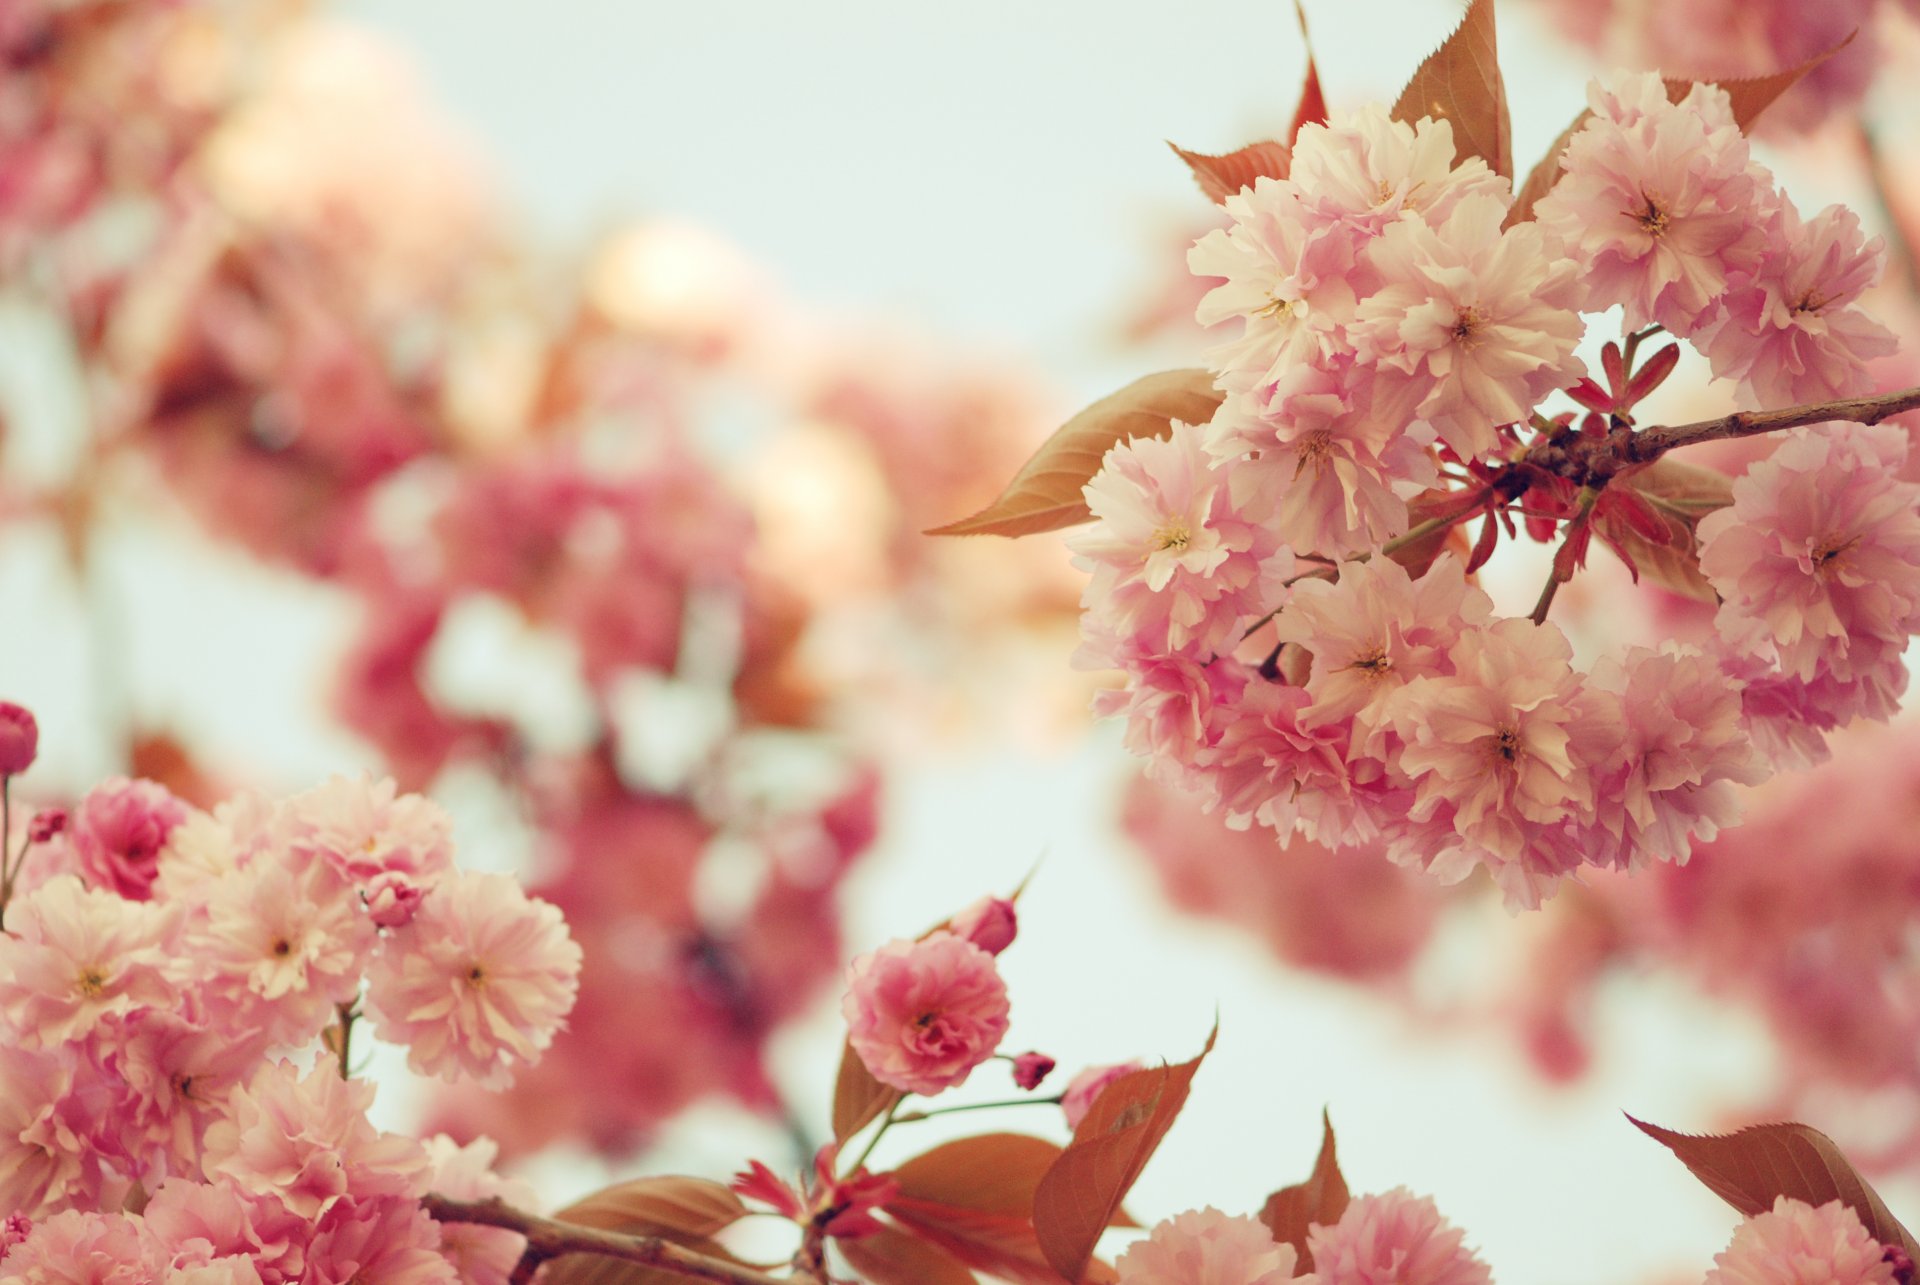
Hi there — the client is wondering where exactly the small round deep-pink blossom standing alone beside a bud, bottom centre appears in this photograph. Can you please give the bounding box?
[841,932,1008,1095]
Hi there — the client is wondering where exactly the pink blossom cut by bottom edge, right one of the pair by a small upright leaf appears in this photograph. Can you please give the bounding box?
[1308,1187,1494,1285]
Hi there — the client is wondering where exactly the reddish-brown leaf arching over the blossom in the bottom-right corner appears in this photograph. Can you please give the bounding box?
[1628,1116,1920,1260]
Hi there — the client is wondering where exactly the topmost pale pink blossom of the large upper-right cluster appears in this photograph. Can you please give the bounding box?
[1534,71,1770,334]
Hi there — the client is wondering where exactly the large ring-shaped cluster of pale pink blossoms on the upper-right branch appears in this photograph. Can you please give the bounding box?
[1069,73,1920,907]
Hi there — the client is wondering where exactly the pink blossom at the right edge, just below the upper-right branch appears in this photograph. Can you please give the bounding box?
[1699,424,1920,682]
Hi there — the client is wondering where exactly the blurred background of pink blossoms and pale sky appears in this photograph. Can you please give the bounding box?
[11,0,1920,1285]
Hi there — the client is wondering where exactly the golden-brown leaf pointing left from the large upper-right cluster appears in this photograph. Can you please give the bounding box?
[925,369,1221,537]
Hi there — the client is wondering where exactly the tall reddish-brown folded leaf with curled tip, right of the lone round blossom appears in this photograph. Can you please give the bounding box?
[1033,1028,1219,1281]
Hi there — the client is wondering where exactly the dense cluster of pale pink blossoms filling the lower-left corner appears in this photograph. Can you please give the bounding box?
[0,718,580,1285]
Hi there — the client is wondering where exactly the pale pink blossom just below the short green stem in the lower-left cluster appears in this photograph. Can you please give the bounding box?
[205,1058,426,1220]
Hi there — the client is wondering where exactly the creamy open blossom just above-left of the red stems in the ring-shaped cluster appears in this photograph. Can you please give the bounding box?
[1352,196,1586,459]
